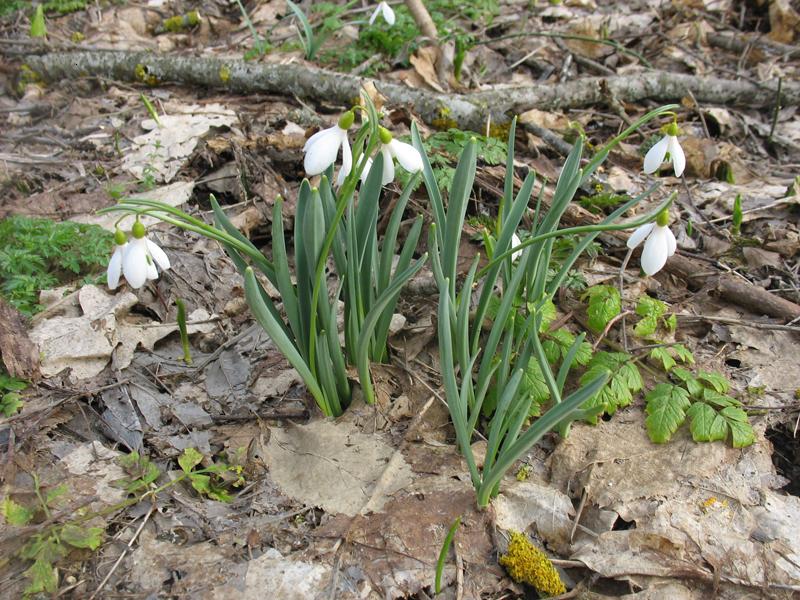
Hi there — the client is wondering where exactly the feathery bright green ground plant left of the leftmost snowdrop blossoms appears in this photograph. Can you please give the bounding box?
[0,216,113,316]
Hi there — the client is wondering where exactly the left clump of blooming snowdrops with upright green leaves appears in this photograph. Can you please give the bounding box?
[106,97,426,417]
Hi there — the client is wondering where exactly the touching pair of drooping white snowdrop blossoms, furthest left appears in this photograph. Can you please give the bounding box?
[107,221,170,290]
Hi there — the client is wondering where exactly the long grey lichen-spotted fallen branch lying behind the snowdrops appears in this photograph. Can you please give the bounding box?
[26,52,800,131]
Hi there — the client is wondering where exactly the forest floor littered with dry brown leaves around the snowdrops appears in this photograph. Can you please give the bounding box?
[0,0,800,600]
